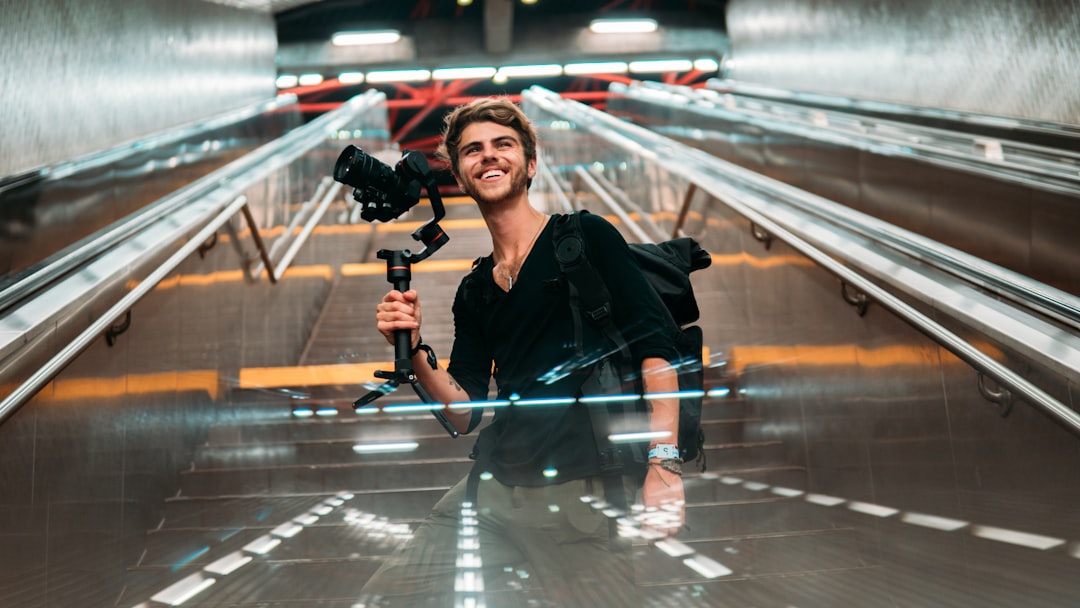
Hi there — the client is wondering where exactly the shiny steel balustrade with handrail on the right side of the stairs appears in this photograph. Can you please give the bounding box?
[523,86,1080,434]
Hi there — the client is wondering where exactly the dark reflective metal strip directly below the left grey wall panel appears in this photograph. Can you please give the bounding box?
[0,98,301,291]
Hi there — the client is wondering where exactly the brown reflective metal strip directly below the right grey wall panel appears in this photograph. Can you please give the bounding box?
[608,80,1080,296]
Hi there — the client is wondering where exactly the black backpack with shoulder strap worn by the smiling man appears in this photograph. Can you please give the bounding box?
[553,211,713,471]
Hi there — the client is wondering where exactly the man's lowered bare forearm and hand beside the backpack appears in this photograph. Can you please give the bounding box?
[642,357,686,535]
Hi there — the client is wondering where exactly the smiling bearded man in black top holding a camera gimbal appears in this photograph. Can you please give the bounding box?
[364,98,684,607]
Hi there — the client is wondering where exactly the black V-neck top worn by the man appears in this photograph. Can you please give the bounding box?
[448,214,675,486]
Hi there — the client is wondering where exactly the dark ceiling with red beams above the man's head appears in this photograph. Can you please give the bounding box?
[239,0,727,159]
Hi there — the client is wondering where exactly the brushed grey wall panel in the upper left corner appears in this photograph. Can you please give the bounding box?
[0,0,278,176]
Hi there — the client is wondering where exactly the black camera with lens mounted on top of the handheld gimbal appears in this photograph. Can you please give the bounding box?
[334,146,427,221]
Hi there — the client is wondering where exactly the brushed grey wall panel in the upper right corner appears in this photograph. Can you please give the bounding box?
[724,0,1080,124]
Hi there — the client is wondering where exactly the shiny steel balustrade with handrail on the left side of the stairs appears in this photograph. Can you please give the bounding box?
[0,91,386,422]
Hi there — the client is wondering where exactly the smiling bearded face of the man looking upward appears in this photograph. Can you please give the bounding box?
[457,122,537,204]
